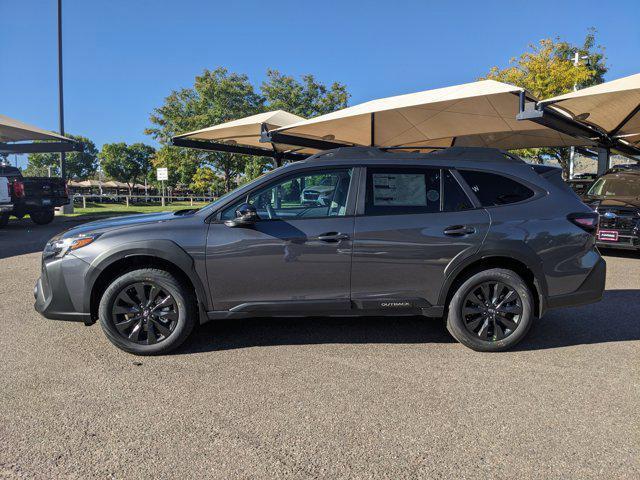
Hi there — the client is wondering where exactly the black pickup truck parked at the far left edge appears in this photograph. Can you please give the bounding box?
[0,164,69,227]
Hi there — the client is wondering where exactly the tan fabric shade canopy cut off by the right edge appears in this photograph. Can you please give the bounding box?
[541,73,640,145]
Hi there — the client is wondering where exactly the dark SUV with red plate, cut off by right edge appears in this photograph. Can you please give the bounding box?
[583,166,640,250]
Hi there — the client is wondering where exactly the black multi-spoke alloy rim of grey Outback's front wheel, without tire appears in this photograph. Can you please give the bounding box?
[111,281,178,345]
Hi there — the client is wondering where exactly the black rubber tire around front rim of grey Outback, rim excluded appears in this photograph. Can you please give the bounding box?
[98,269,194,355]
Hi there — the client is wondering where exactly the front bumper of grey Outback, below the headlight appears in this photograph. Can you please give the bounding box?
[33,254,93,325]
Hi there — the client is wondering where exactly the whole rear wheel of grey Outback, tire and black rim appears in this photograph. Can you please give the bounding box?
[447,268,534,352]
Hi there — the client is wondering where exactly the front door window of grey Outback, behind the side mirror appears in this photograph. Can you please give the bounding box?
[222,169,351,220]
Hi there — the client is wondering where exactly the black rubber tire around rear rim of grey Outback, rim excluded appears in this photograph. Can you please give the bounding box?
[447,268,535,352]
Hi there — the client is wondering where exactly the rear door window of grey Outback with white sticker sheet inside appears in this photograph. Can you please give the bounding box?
[365,168,440,215]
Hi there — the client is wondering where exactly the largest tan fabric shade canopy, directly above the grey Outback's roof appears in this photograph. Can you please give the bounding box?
[274,80,589,149]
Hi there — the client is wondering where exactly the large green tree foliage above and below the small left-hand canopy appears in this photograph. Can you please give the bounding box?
[145,68,348,191]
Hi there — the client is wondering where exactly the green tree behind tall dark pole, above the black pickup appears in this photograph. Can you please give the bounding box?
[25,135,98,178]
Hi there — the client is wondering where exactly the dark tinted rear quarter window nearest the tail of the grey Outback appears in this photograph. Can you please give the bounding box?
[460,170,533,207]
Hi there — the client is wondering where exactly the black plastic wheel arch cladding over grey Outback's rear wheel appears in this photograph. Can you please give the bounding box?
[438,255,545,317]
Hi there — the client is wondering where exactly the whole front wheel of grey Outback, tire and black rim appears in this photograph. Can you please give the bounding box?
[98,268,197,355]
